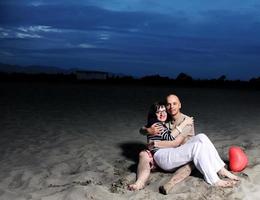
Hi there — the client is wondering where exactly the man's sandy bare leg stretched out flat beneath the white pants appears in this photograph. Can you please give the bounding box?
[159,163,194,195]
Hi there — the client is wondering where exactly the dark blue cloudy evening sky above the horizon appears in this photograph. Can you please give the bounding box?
[0,0,260,80]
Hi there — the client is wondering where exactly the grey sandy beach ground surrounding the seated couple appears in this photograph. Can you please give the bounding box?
[0,83,260,200]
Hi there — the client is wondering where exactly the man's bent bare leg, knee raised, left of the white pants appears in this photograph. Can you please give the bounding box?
[128,151,153,190]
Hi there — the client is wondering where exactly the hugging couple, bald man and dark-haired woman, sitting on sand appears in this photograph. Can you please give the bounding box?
[129,94,239,194]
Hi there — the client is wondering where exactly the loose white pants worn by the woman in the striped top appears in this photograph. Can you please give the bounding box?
[154,133,225,184]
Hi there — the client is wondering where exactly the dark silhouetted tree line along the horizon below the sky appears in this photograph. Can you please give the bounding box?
[0,72,260,89]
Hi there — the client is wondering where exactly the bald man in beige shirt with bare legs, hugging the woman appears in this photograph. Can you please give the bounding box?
[129,94,194,194]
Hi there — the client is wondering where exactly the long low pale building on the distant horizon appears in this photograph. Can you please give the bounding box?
[75,71,108,80]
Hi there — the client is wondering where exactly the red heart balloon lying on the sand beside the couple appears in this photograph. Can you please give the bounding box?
[229,146,248,172]
